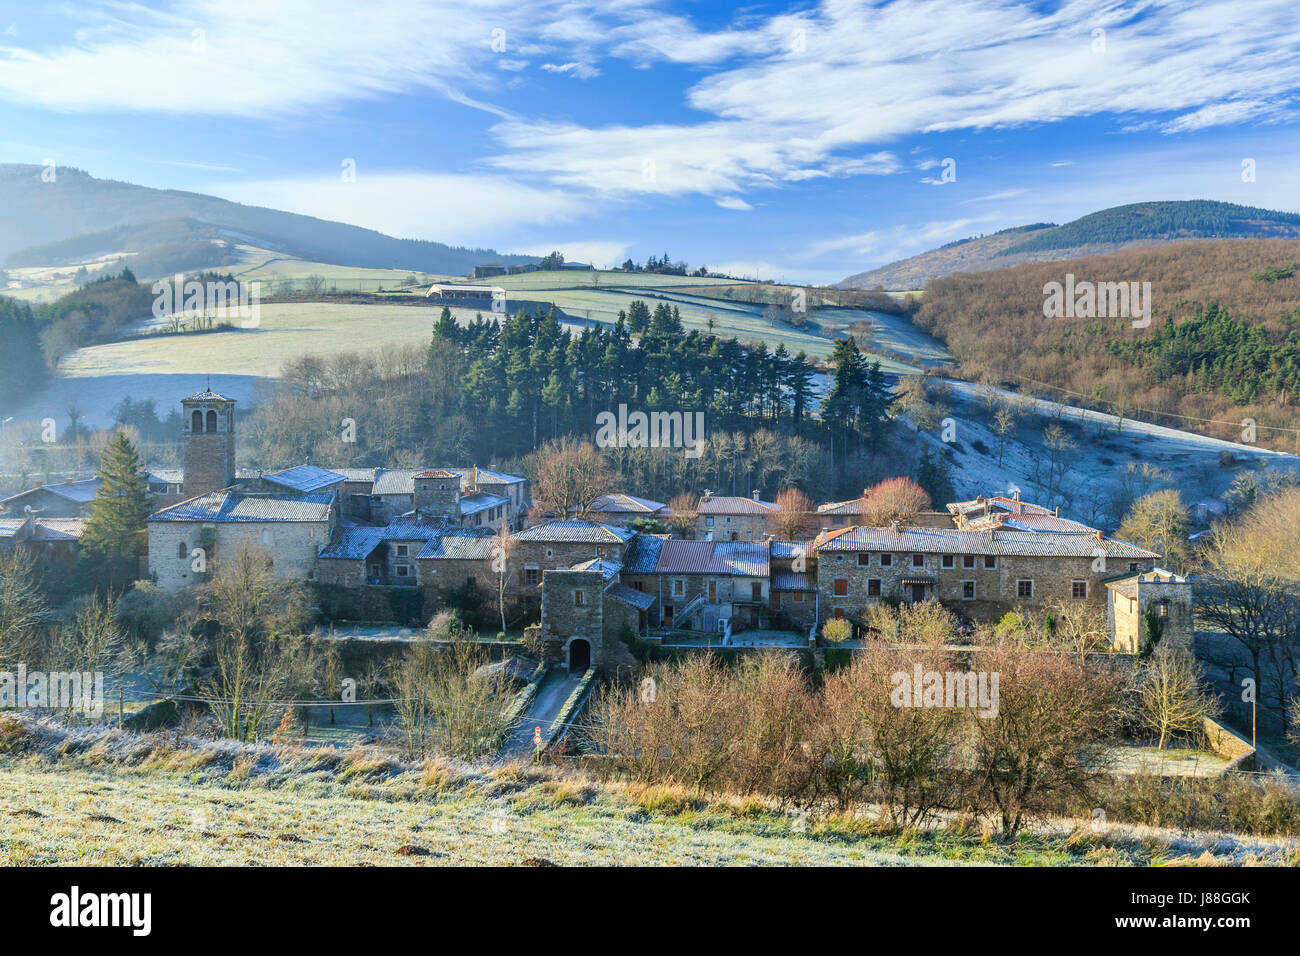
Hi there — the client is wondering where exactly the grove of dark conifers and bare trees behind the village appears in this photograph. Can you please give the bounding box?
[242,300,943,501]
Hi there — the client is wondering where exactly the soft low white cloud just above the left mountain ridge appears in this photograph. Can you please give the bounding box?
[200,166,586,252]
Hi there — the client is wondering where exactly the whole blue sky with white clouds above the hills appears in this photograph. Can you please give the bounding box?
[0,0,1300,282]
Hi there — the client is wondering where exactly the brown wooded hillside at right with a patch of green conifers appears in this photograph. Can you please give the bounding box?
[915,239,1300,450]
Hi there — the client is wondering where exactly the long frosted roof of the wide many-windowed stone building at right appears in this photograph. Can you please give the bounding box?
[815,525,1160,558]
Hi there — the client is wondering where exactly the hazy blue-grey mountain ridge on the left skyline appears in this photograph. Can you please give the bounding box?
[0,164,538,277]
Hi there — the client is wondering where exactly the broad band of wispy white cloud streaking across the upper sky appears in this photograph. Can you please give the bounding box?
[0,0,1300,214]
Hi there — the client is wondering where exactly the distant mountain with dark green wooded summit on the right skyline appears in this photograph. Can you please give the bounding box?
[837,199,1300,289]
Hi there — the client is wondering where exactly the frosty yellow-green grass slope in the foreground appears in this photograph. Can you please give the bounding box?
[0,715,1286,865]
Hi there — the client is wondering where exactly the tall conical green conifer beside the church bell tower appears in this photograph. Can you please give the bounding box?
[78,432,152,592]
